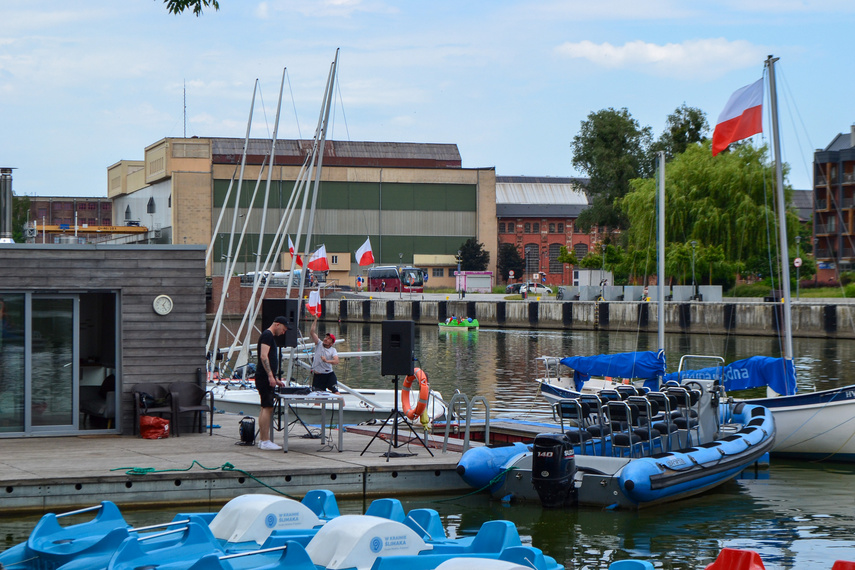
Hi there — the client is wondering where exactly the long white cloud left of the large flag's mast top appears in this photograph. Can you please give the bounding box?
[555,38,768,79]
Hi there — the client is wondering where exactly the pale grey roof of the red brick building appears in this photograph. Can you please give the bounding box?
[496,176,588,207]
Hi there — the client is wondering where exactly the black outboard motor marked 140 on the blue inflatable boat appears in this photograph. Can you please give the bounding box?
[531,433,576,508]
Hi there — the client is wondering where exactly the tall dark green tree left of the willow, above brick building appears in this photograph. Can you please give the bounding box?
[570,108,651,231]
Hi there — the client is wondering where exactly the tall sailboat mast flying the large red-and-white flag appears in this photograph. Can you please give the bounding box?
[766,55,793,361]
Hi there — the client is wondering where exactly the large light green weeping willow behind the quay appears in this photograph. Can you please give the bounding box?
[620,141,798,275]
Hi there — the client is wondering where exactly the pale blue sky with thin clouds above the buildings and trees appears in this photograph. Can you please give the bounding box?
[0,0,855,196]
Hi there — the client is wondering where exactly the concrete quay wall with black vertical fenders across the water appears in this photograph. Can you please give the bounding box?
[322,298,855,338]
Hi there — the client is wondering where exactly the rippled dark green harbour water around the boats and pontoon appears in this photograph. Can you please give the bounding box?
[0,324,855,570]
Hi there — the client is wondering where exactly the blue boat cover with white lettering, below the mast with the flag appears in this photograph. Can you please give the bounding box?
[665,356,796,396]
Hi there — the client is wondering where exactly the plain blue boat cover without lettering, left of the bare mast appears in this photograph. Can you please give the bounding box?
[561,350,665,390]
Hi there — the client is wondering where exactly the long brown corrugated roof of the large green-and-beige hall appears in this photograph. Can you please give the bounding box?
[211,138,462,168]
